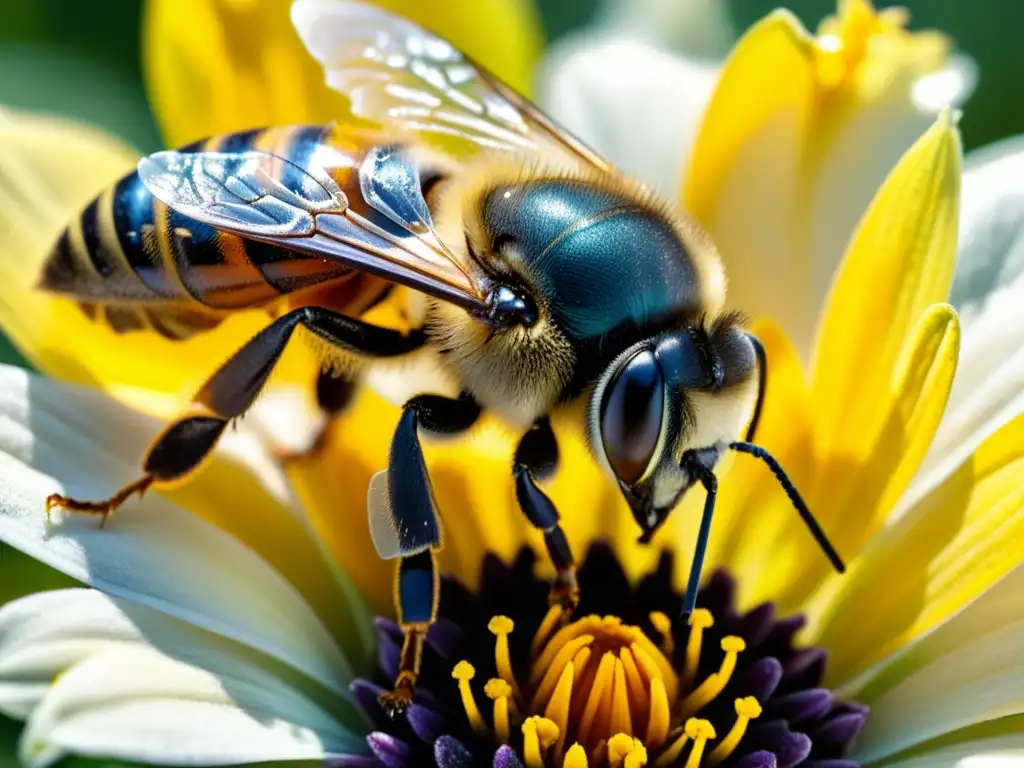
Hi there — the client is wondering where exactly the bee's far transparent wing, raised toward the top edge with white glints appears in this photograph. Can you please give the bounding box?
[292,0,609,170]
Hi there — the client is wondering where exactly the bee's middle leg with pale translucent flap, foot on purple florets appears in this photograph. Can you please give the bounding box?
[371,394,480,717]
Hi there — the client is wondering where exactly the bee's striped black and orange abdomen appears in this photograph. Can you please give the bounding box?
[40,126,386,339]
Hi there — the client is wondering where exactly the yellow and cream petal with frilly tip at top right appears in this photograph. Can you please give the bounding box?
[682,2,948,360]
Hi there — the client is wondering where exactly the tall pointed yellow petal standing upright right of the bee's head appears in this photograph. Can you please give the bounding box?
[811,112,961,458]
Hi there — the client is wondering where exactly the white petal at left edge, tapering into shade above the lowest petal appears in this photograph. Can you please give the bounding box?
[0,589,361,723]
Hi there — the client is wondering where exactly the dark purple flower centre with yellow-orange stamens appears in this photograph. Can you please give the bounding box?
[353,544,866,768]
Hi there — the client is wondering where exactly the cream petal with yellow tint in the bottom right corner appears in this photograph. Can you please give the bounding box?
[853,561,1024,763]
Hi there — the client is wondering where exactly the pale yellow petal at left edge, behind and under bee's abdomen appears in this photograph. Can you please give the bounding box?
[0,113,311,416]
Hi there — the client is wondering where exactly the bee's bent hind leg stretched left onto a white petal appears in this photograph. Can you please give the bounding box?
[46,306,425,524]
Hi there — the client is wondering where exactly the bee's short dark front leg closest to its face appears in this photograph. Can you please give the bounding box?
[512,418,580,618]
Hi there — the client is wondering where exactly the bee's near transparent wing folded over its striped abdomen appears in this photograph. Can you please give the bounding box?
[138,147,483,311]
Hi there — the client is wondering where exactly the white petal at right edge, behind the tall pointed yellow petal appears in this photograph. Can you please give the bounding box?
[897,138,1024,514]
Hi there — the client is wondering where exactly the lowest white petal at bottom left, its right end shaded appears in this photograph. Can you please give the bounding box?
[19,646,366,768]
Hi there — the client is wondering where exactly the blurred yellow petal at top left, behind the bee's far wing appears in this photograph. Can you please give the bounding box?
[143,0,541,146]
